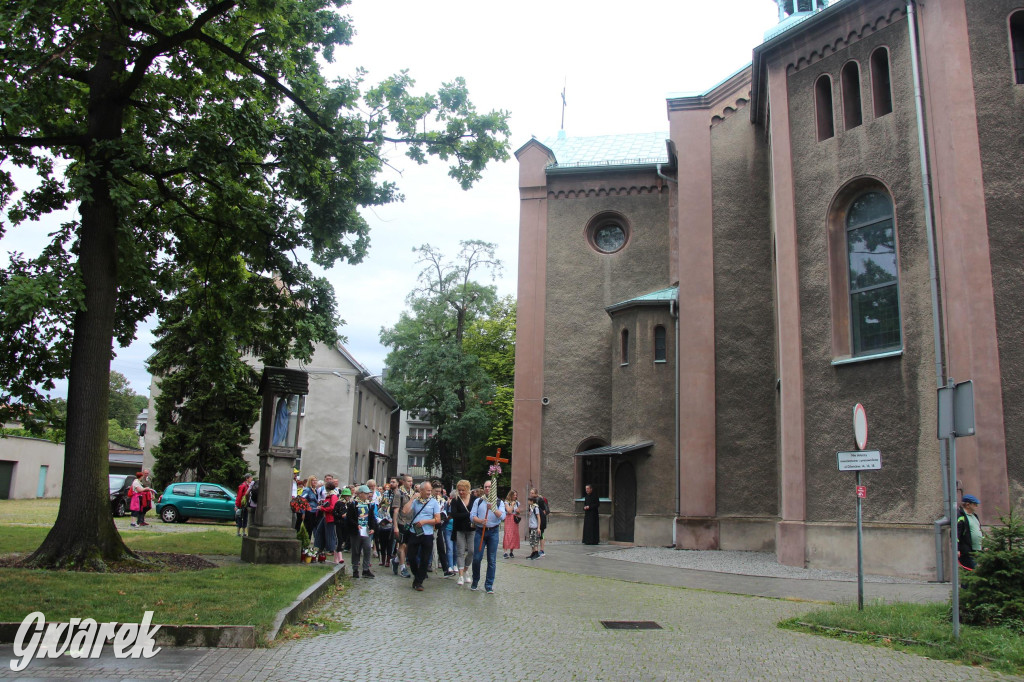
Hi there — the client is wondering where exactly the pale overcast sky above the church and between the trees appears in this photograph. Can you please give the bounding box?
[0,0,778,394]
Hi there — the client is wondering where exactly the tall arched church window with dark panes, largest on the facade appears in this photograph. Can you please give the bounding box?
[846,191,901,355]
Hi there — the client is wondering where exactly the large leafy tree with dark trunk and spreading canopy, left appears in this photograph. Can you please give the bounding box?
[0,0,508,568]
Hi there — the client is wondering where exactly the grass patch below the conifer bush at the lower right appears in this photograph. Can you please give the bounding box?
[779,603,1024,675]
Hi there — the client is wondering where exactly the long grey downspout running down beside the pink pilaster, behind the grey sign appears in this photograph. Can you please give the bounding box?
[906,0,956,583]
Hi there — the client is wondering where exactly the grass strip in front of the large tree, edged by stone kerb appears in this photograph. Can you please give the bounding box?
[0,564,330,639]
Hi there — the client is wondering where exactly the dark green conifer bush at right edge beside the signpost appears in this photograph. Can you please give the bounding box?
[961,509,1024,634]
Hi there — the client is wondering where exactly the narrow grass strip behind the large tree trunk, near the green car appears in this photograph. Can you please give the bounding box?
[0,525,242,555]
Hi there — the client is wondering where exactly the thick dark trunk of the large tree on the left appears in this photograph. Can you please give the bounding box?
[26,38,138,570]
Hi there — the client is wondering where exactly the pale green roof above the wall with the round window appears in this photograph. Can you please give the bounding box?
[544,131,669,170]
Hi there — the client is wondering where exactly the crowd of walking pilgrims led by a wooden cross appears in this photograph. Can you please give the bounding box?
[237,470,549,594]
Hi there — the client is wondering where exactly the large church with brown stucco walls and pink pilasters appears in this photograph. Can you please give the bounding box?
[512,0,1024,578]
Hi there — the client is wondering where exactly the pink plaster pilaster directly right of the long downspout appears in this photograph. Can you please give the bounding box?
[919,0,1010,523]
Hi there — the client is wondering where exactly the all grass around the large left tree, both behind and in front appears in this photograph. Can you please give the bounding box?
[0,516,331,641]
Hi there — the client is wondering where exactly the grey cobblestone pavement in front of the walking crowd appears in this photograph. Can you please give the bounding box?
[0,560,1010,682]
